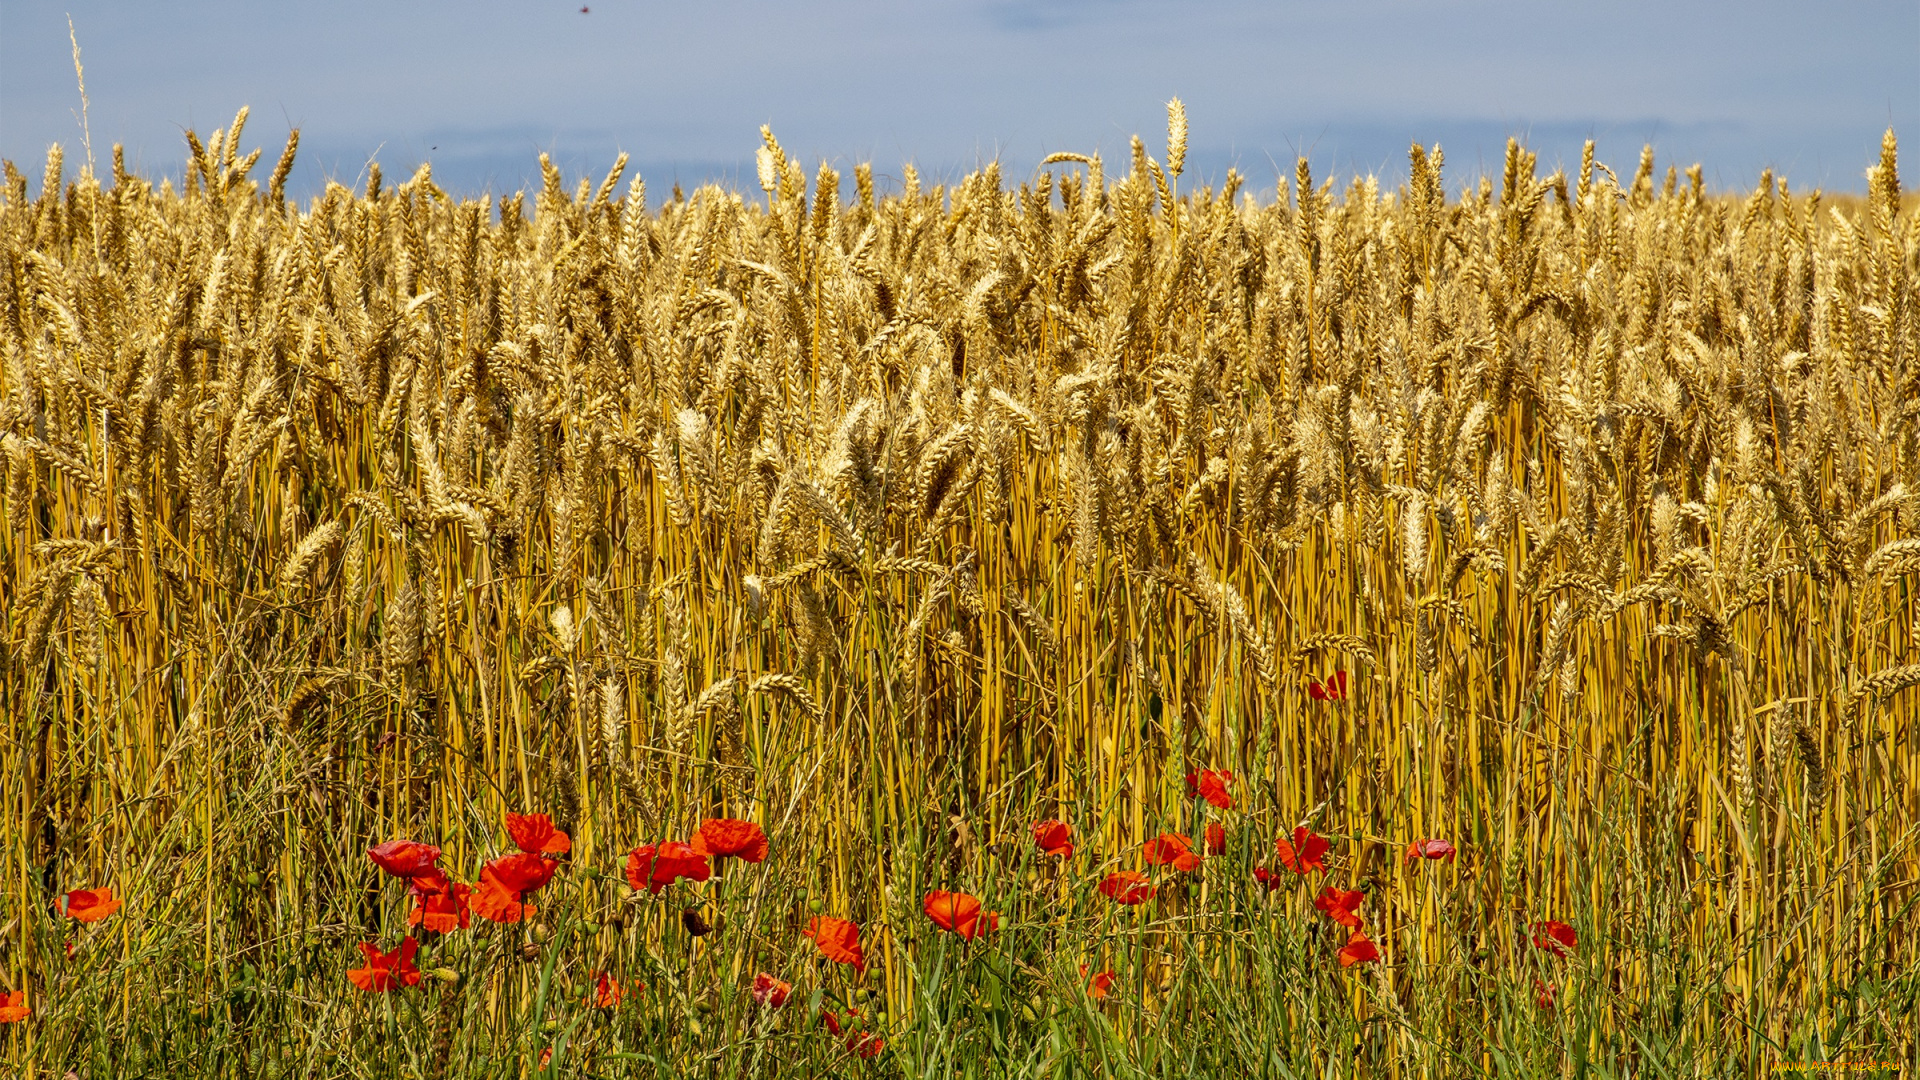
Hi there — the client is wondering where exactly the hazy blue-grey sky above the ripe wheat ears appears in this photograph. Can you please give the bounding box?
[0,0,1920,202]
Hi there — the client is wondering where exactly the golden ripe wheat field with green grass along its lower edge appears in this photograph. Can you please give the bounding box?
[0,104,1920,1080]
